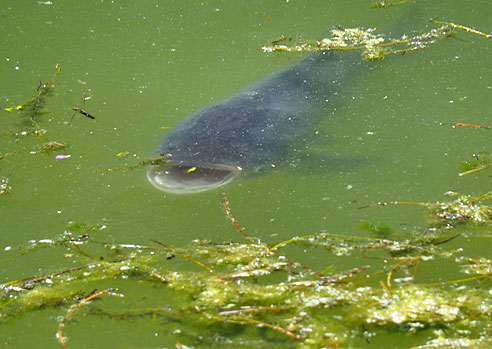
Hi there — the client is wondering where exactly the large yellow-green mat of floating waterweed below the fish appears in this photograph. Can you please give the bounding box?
[0,193,492,348]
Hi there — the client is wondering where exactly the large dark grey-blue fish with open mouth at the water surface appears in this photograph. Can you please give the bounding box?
[147,51,368,194]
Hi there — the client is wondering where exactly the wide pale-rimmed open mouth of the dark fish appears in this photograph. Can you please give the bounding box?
[147,162,241,194]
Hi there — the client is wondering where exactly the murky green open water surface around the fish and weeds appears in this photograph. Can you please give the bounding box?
[0,0,492,348]
